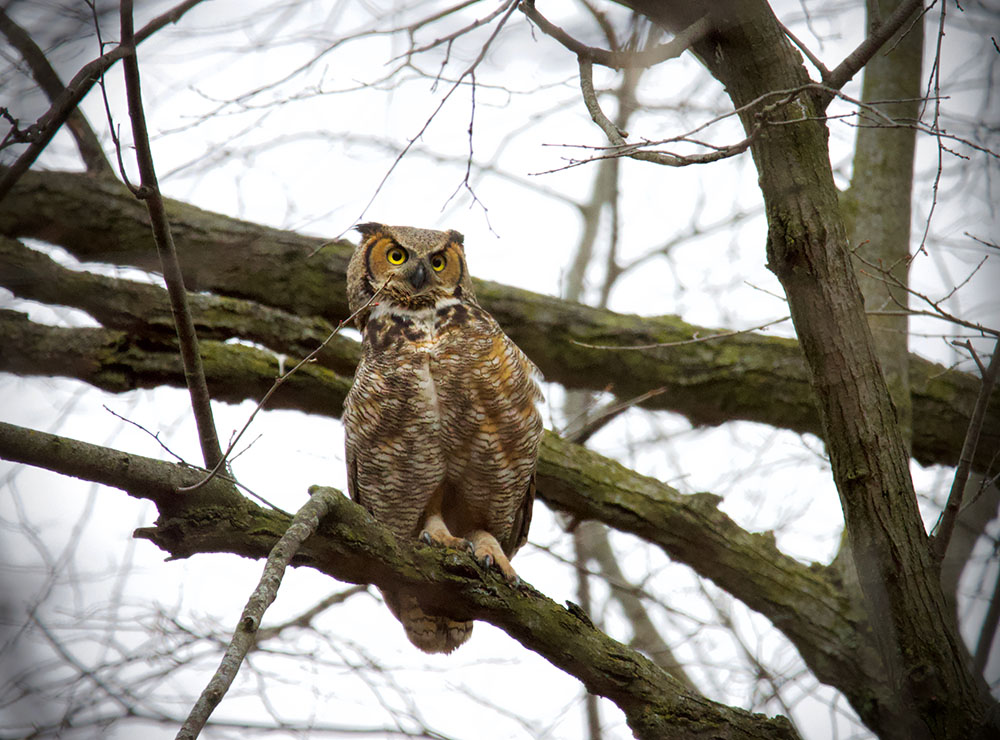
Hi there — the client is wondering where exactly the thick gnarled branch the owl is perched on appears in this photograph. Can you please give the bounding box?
[0,423,798,740]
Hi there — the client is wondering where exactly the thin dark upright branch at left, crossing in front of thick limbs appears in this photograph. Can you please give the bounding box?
[119,0,222,467]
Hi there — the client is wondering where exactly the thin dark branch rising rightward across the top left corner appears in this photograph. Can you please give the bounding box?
[0,0,201,200]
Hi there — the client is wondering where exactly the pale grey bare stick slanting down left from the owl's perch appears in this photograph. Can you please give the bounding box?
[177,488,337,740]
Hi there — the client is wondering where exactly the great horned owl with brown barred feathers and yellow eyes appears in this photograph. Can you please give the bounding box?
[343,223,542,653]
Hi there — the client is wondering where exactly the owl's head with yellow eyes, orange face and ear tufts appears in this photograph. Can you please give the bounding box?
[347,223,475,326]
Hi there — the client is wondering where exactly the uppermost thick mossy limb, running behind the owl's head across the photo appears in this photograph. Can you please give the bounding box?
[0,172,1000,470]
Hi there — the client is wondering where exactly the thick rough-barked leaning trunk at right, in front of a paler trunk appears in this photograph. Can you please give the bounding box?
[616,0,991,739]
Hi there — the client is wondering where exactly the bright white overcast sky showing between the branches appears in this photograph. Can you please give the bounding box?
[0,0,1000,739]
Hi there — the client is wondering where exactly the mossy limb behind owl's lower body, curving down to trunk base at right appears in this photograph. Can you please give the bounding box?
[0,311,900,732]
